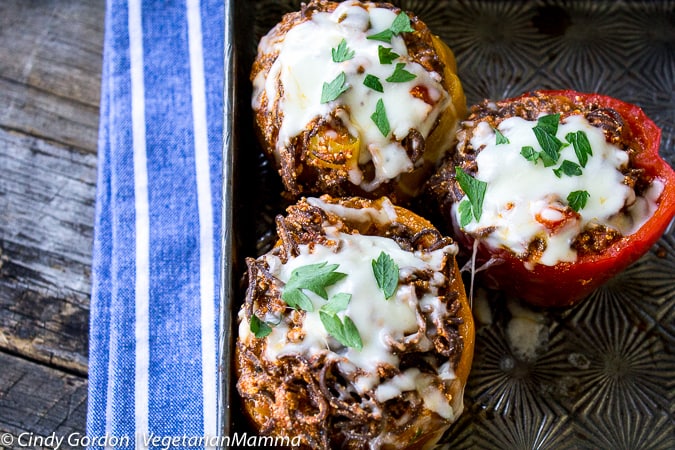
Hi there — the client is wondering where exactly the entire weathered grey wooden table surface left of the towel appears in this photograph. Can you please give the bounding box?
[0,0,105,442]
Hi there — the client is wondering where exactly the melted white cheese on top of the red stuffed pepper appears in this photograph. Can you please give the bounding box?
[453,115,663,266]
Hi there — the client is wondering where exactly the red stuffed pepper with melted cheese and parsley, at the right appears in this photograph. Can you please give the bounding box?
[429,90,675,307]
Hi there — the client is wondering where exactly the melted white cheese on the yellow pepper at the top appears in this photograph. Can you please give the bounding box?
[253,1,451,191]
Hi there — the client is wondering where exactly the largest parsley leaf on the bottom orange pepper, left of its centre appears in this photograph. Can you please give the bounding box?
[281,262,347,311]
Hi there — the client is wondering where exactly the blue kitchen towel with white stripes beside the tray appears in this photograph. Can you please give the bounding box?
[86,0,224,448]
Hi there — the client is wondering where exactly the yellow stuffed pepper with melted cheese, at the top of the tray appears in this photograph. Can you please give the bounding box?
[251,1,466,203]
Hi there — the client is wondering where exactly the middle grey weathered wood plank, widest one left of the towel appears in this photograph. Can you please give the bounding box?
[0,129,96,374]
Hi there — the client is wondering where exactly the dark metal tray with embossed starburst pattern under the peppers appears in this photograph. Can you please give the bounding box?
[220,0,675,449]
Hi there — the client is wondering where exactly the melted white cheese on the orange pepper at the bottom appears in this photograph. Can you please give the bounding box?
[239,199,457,419]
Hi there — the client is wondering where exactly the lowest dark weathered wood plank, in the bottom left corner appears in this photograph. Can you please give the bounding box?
[0,352,87,449]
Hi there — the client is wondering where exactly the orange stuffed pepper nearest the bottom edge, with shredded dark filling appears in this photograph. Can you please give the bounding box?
[235,196,474,449]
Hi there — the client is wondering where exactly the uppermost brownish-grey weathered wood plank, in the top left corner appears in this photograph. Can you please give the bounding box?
[0,0,105,153]
